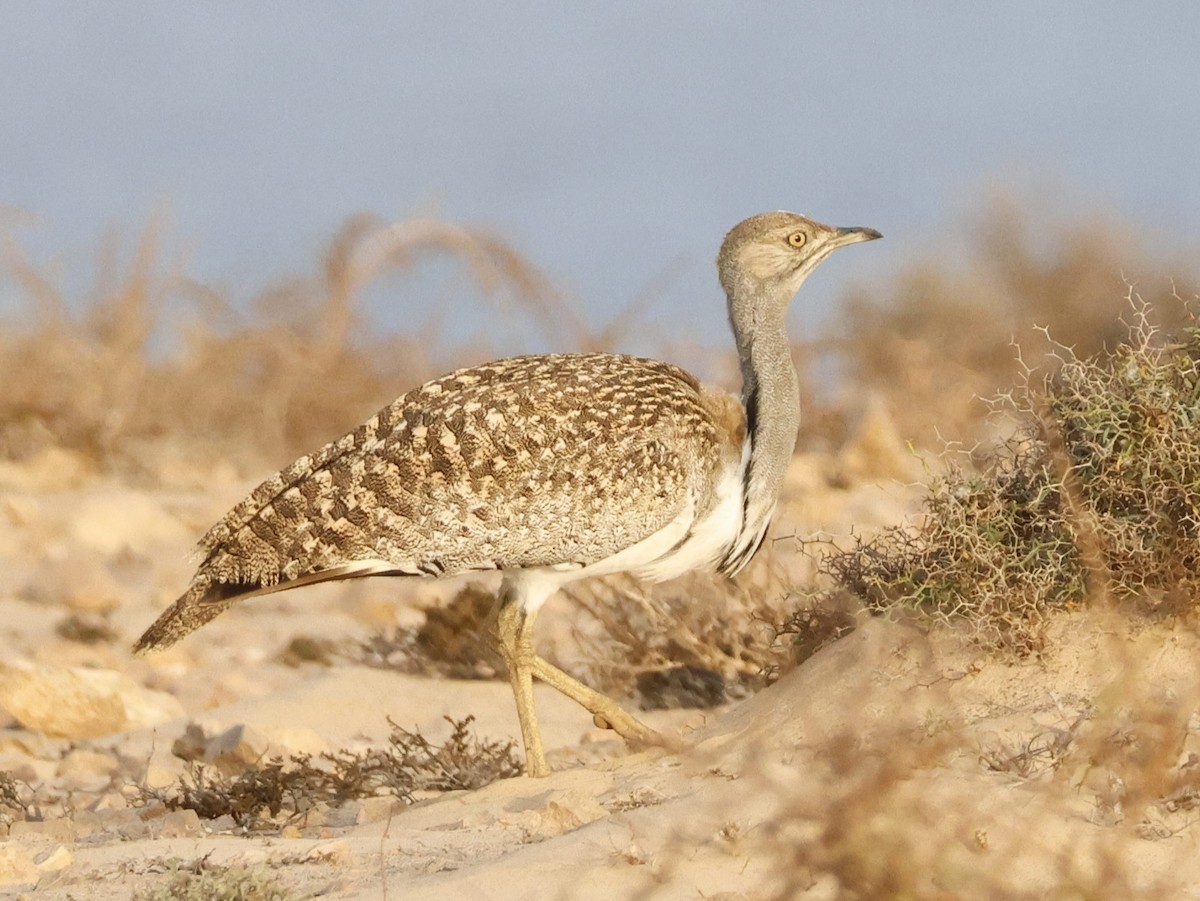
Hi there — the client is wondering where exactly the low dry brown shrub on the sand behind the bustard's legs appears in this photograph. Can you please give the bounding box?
[343,573,806,709]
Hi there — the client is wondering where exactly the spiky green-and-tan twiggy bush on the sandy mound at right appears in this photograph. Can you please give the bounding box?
[821,299,1200,648]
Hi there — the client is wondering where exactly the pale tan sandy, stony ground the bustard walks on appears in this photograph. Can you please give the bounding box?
[0,424,1200,899]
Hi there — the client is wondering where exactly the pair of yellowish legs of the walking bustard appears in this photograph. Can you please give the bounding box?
[492,591,670,776]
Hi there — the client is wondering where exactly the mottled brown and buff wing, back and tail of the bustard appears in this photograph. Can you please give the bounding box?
[131,354,740,647]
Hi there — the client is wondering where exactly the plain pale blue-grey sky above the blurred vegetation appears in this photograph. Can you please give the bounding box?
[0,0,1200,349]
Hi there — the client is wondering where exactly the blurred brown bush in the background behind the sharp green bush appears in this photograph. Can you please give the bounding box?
[834,196,1200,448]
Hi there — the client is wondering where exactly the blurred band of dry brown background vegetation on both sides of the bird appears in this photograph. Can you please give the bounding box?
[0,196,1200,480]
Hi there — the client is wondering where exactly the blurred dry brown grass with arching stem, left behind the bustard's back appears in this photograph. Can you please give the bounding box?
[0,216,566,471]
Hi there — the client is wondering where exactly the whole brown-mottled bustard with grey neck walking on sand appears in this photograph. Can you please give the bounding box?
[136,212,880,776]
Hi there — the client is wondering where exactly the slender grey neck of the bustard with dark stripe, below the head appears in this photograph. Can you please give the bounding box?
[722,285,800,575]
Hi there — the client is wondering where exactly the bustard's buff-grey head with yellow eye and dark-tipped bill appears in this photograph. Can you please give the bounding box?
[716,211,882,304]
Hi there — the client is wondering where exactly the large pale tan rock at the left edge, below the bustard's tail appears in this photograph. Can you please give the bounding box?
[0,661,184,738]
